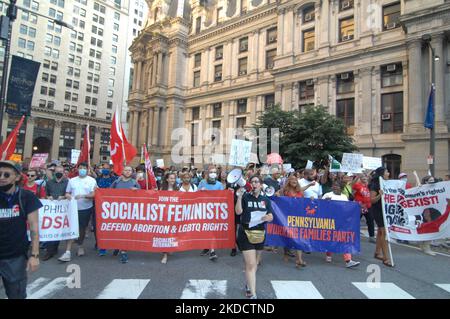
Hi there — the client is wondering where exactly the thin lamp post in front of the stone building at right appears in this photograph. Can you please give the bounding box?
[422,34,439,180]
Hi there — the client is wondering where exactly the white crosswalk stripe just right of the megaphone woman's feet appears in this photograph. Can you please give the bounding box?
[271,280,323,299]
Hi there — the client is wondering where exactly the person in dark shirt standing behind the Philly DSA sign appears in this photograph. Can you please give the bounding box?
[42,166,69,261]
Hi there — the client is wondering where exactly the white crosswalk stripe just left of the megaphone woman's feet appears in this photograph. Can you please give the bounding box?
[180,279,227,299]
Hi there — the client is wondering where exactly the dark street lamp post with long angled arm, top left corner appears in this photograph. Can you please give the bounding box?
[0,0,73,144]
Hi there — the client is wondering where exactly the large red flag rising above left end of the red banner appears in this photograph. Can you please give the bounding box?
[110,112,137,175]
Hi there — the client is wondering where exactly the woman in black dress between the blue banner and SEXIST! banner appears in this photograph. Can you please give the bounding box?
[369,167,393,267]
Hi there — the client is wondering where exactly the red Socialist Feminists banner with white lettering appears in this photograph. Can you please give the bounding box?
[95,189,235,252]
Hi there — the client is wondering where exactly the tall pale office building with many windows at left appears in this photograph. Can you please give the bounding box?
[0,0,144,163]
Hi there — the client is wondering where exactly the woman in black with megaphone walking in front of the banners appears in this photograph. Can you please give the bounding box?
[236,176,273,299]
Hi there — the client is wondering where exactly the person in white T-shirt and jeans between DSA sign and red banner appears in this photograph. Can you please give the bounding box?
[58,163,98,262]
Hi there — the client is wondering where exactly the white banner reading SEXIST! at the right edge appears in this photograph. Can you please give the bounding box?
[380,180,450,241]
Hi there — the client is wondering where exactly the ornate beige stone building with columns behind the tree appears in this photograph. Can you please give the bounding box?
[128,0,450,176]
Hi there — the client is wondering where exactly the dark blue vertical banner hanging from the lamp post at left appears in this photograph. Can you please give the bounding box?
[6,55,41,116]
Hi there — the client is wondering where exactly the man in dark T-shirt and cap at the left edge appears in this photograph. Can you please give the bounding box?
[0,161,42,299]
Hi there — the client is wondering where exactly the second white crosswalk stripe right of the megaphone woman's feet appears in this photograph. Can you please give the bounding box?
[352,282,415,299]
